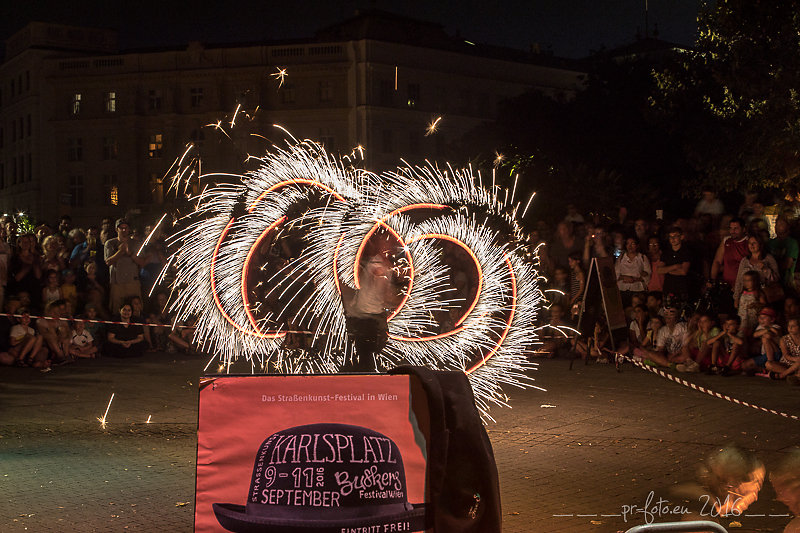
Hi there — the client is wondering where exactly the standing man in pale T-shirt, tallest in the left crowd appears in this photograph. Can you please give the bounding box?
[104,218,146,310]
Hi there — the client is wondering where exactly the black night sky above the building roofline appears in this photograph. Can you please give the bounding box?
[0,0,700,57]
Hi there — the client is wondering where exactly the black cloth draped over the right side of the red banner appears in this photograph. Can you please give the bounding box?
[389,366,502,533]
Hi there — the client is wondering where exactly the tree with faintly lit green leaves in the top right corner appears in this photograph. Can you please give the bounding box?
[652,0,800,191]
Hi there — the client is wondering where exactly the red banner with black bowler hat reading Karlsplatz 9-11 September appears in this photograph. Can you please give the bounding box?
[195,375,427,533]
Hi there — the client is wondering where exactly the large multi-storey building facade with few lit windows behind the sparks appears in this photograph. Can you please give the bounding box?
[0,11,582,225]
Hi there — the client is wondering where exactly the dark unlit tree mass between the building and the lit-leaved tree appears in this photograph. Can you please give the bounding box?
[462,51,691,222]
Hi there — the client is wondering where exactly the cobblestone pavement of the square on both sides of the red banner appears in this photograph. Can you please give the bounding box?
[0,354,800,533]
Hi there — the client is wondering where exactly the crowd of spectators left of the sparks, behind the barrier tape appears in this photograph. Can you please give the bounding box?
[0,216,195,371]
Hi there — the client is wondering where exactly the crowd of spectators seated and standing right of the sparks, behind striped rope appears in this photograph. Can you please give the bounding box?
[532,190,800,384]
